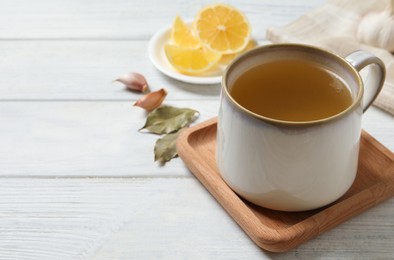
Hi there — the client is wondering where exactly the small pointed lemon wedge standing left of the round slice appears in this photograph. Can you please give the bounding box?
[171,16,201,48]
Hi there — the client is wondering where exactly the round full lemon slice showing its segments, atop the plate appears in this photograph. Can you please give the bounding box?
[194,4,251,54]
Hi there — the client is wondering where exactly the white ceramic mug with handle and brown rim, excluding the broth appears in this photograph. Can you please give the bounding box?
[216,44,385,211]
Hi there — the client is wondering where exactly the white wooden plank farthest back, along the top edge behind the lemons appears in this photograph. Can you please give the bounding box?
[0,0,324,40]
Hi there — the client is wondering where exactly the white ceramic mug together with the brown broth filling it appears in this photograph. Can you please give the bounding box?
[216,44,385,211]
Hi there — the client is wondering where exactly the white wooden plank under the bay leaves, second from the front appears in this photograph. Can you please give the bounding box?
[0,101,394,176]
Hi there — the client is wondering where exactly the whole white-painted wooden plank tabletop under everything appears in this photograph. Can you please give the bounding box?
[0,0,394,259]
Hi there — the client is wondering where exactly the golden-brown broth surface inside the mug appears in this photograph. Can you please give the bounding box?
[230,60,352,122]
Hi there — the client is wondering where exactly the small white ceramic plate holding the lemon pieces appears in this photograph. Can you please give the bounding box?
[148,22,224,84]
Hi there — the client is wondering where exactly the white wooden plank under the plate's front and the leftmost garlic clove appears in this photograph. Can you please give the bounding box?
[0,41,220,100]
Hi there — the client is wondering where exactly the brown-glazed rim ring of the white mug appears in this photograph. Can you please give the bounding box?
[221,43,364,126]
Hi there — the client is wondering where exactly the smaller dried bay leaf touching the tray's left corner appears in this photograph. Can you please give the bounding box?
[154,130,182,164]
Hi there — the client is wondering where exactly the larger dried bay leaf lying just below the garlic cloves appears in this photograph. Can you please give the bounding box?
[140,106,199,134]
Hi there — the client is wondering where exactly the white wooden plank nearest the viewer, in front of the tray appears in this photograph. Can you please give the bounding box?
[0,178,394,259]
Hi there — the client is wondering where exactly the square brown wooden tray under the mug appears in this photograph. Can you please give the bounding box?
[177,118,394,252]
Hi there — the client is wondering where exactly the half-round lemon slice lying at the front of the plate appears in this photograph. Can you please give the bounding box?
[164,43,221,74]
